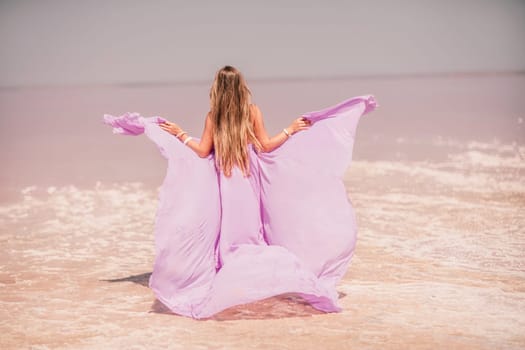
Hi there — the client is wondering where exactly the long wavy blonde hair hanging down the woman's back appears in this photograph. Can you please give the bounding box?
[210,66,262,177]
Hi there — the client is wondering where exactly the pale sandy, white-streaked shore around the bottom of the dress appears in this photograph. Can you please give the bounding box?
[0,139,525,349]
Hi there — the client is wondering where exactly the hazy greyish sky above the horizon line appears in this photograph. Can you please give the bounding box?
[0,0,525,86]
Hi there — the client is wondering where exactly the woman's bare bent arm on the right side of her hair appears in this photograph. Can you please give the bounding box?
[250,105,311,152]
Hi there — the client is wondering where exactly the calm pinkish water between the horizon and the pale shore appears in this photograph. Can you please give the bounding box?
[0,75,525,201]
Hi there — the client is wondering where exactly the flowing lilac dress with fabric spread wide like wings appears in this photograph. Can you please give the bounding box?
[104,95,376,318]
